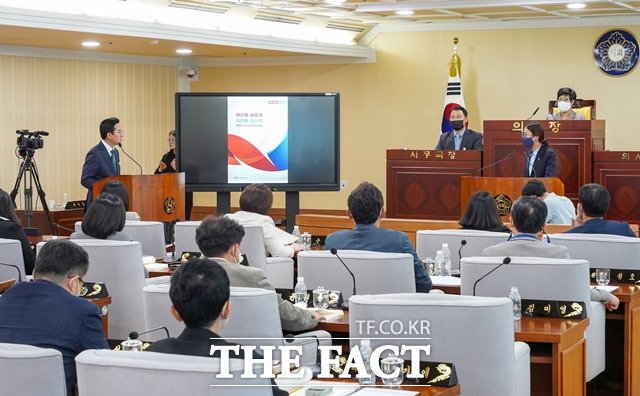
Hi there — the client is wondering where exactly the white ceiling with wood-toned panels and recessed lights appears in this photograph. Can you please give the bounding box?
[0,0,640,64]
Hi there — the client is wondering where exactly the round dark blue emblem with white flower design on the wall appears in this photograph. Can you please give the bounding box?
[593,29,638,77]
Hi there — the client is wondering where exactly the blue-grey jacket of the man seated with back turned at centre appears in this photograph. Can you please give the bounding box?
[324,224,432,293]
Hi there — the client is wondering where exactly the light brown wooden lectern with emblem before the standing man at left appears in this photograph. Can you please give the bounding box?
[93,172,185,222]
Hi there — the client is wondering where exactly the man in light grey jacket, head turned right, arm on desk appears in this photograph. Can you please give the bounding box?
[196,216,323,331]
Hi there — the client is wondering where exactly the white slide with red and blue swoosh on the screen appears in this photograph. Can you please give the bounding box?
[227,96,289,183]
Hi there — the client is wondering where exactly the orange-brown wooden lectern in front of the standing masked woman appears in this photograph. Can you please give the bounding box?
[460,176,564,216]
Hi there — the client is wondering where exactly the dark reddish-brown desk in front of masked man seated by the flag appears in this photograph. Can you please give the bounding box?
[386,149,482,220]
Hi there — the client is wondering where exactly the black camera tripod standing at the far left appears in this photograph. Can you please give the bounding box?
[10,150,56,236]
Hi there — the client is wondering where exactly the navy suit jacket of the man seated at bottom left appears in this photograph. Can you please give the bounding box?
[0,280,109,395]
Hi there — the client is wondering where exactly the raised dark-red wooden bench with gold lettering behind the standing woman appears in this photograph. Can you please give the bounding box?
[483,120,605,201]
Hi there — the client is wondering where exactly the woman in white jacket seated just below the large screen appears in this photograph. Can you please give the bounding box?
[226,184,303,257]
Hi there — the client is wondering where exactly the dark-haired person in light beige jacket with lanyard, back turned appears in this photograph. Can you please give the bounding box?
[482,196,620,311]
